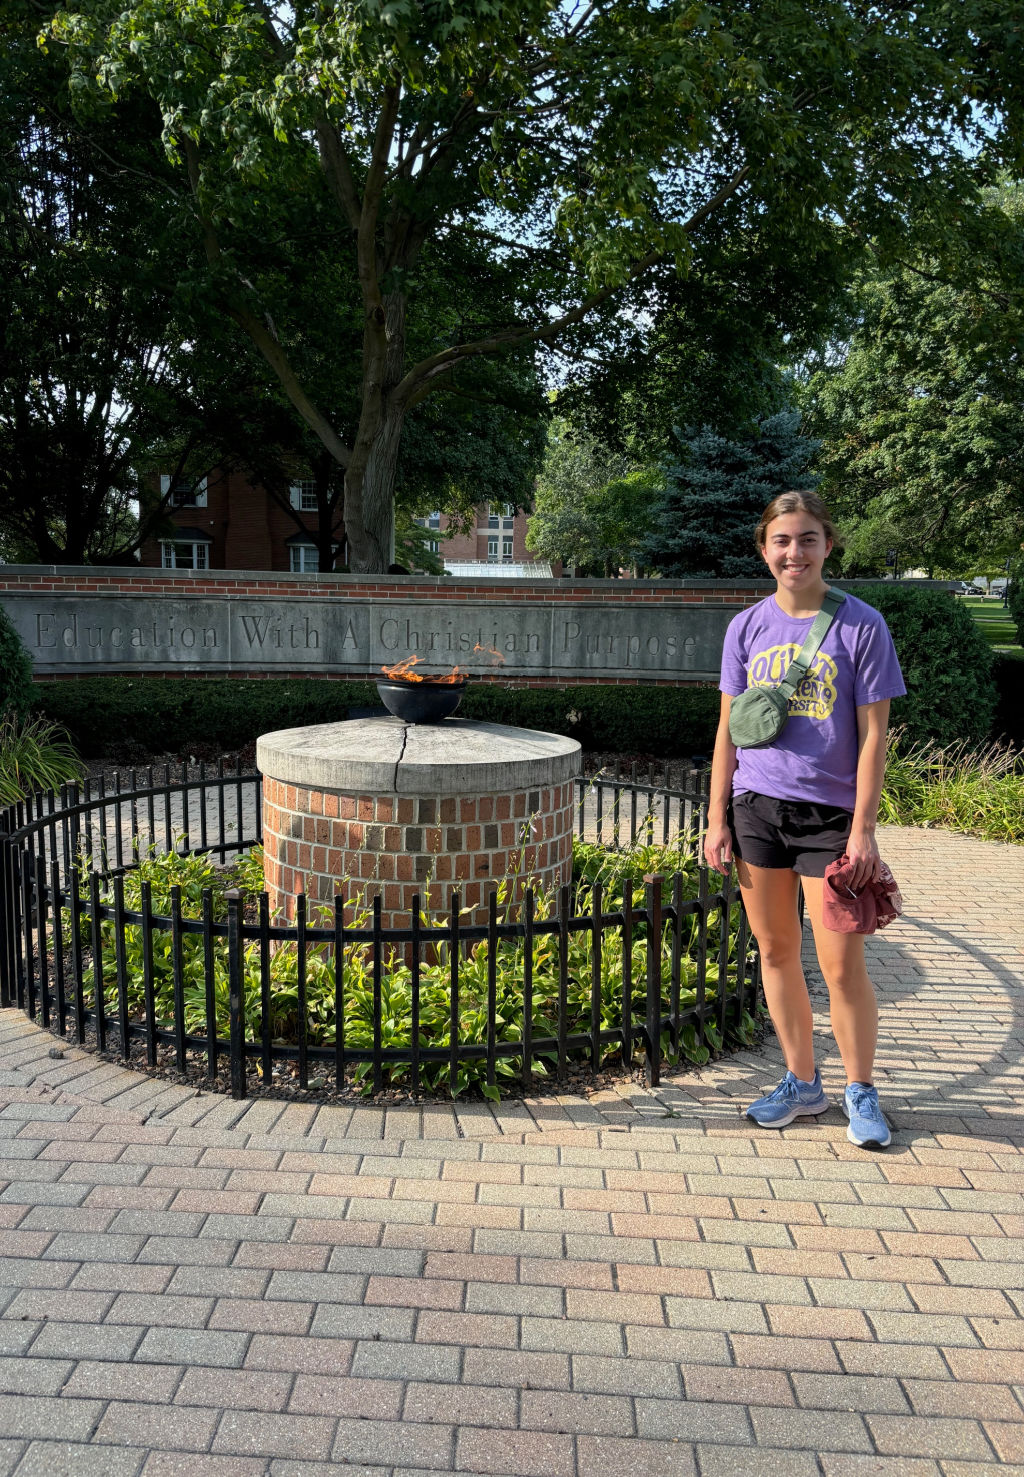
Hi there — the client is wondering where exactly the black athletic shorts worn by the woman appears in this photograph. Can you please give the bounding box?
[728,790,853,877]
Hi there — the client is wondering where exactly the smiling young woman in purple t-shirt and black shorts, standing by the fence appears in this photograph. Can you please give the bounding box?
[705,492,906,1149]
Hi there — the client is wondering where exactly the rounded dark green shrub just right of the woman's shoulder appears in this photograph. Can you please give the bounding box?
[857,583,996,744]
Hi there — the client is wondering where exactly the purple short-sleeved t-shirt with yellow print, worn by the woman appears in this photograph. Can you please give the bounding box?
[718,595,906,811]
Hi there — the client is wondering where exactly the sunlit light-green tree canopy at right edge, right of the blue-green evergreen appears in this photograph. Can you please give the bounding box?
[804,189,1024,572]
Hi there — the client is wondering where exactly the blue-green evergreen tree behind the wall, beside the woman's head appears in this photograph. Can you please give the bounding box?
[643,411,822,579]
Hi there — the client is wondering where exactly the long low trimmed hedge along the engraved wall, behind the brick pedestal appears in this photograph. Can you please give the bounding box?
[33,676,718,758]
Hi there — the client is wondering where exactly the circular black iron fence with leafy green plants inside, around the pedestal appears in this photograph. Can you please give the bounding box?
[0,765,750,1097]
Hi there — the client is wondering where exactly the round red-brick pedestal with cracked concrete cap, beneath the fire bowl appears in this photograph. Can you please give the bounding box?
[256,718,579,928]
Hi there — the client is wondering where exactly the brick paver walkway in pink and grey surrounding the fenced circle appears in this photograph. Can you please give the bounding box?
[0,832,1024,1477]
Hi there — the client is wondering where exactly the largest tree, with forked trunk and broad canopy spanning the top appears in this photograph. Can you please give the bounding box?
[41,0,1021,569]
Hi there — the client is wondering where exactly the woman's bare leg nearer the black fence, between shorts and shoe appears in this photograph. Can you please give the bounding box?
[736,860,814,1083]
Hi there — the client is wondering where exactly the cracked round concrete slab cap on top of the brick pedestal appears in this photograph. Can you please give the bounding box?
[256,716,581,795]
